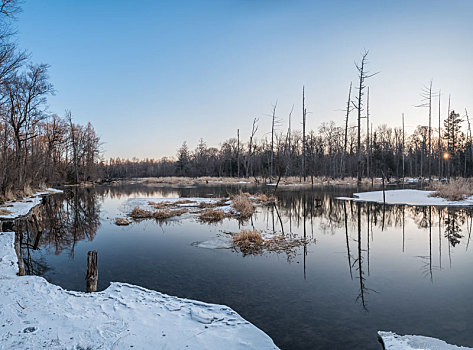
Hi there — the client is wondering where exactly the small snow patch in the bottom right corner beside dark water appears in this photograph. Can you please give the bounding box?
[378,331,471,350]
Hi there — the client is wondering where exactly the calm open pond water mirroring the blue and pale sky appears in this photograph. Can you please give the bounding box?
[22,185,473,349]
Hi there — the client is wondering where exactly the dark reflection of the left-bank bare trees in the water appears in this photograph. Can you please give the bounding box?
[15,188,100,275]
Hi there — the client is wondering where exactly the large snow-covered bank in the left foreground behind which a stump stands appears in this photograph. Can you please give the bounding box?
[0,232,277,349]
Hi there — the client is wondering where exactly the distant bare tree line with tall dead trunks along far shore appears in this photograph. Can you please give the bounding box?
[102,52,473,181]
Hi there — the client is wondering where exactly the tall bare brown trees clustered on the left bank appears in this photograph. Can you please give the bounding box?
[0,0,100,199]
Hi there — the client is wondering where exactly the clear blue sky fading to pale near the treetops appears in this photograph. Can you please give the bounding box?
[15,0,473,159]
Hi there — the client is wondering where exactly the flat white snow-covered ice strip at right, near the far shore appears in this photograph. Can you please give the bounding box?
[338,190,473,207]
